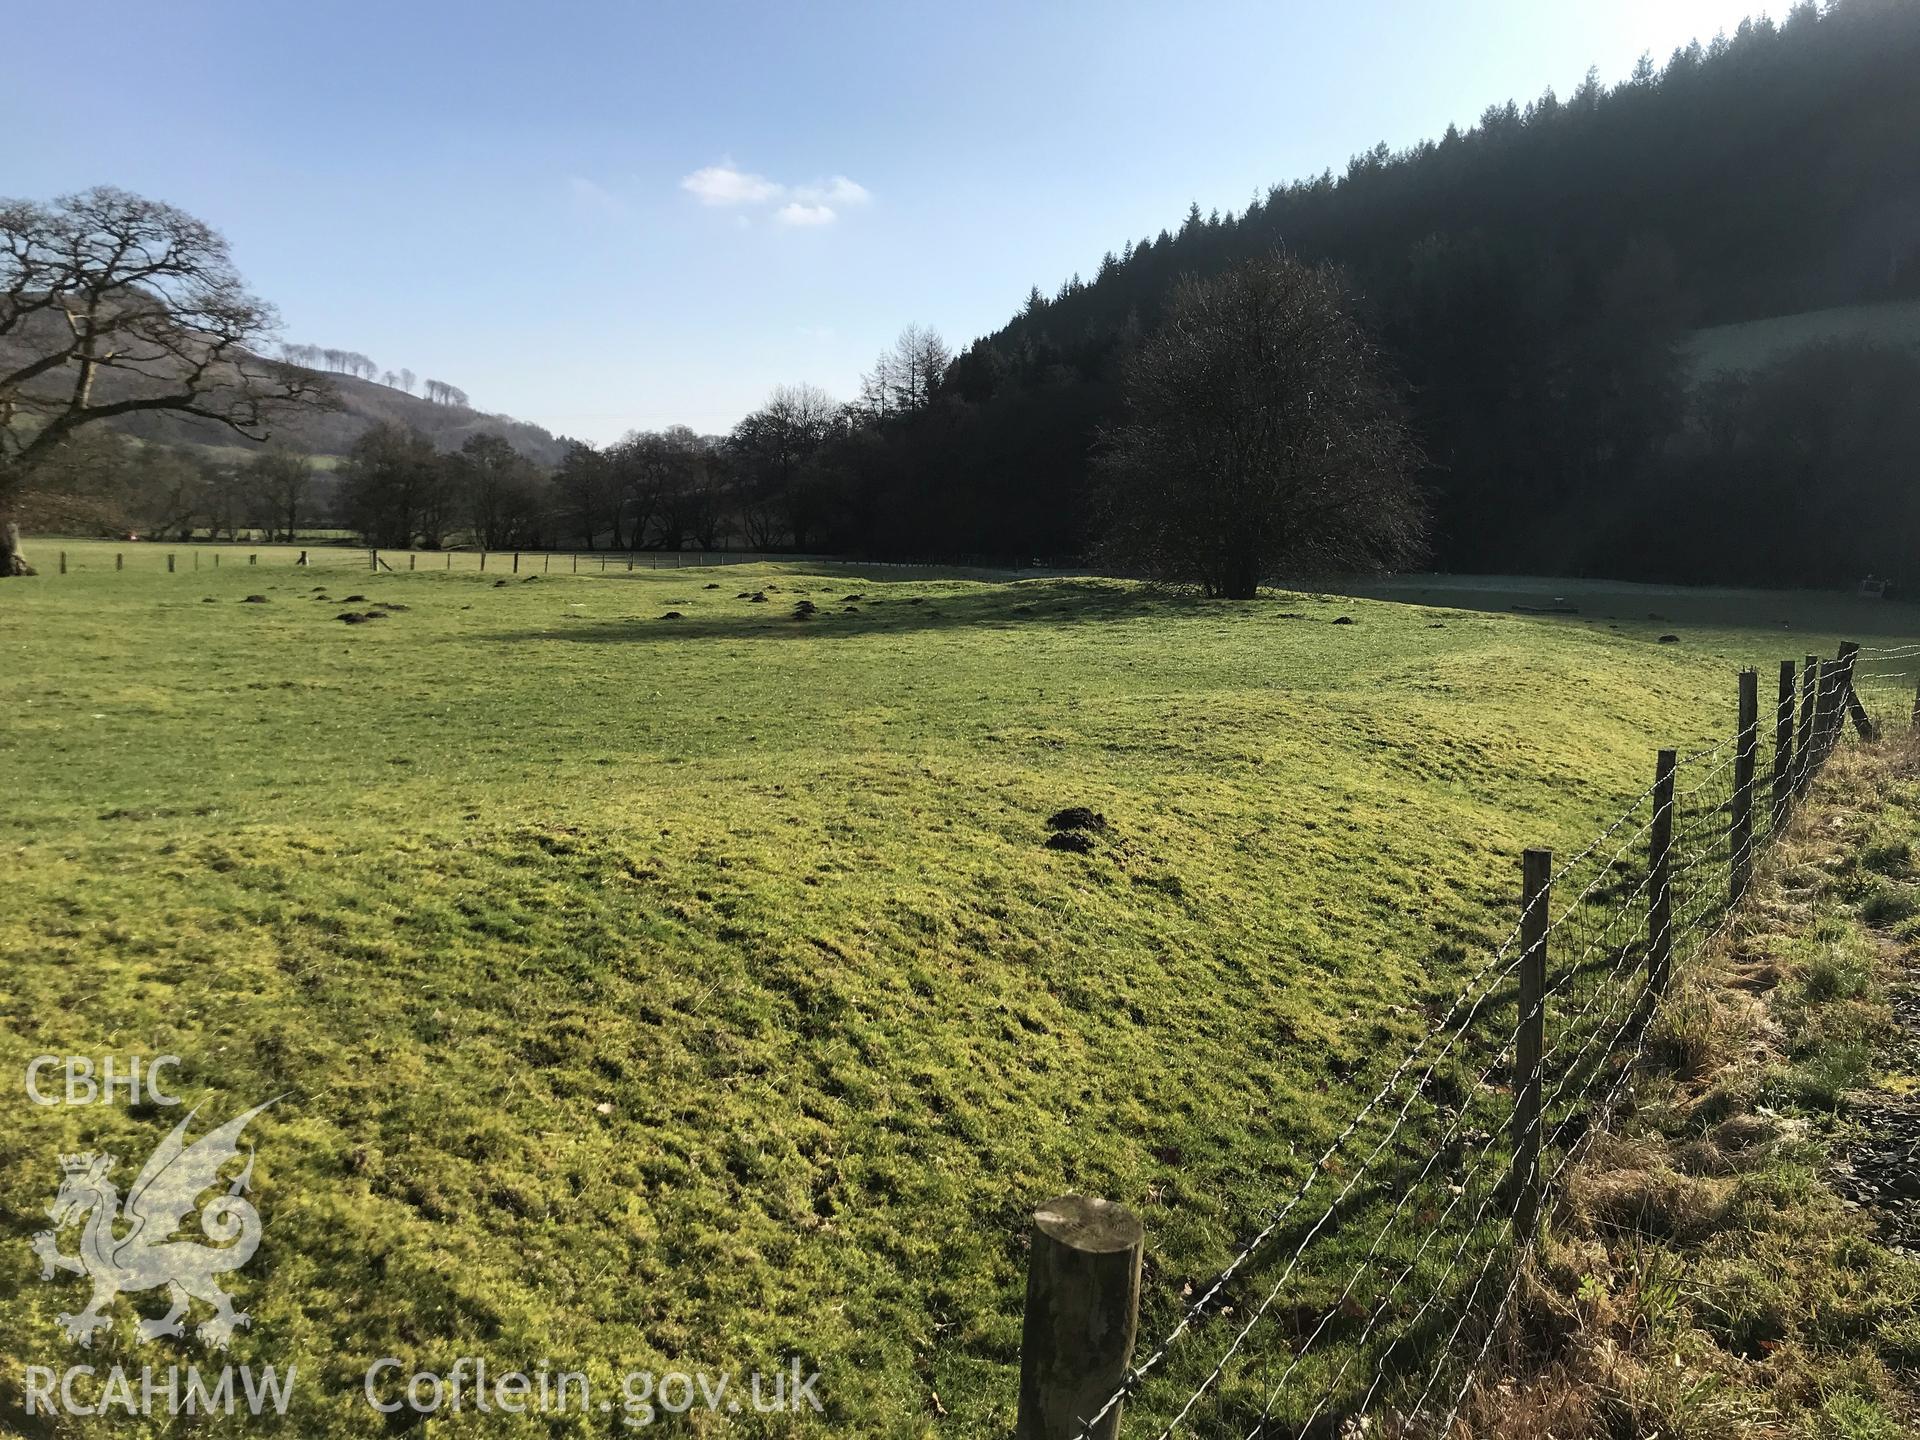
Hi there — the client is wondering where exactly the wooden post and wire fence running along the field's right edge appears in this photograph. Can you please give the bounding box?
[1018,643,1920,1440]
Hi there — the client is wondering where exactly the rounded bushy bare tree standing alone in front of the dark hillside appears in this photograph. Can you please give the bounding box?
[1100,253,1425,599]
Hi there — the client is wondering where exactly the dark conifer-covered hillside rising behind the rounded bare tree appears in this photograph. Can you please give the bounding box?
[829,0,1920,580]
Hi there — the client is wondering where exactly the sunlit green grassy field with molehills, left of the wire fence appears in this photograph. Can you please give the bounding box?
[0,556,1920,1436]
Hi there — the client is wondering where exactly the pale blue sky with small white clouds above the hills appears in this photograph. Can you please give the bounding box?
[0,0,1751,442]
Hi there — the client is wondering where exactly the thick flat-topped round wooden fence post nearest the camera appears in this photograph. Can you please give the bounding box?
[1014,1194,1146,1440]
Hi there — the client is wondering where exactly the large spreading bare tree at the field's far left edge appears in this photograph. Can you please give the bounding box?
[0,186,330,576]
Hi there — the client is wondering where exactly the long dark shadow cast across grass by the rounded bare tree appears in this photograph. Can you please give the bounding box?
[487,580,1236,645]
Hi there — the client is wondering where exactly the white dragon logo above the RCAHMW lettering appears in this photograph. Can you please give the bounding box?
[33,1096,278,1350]
